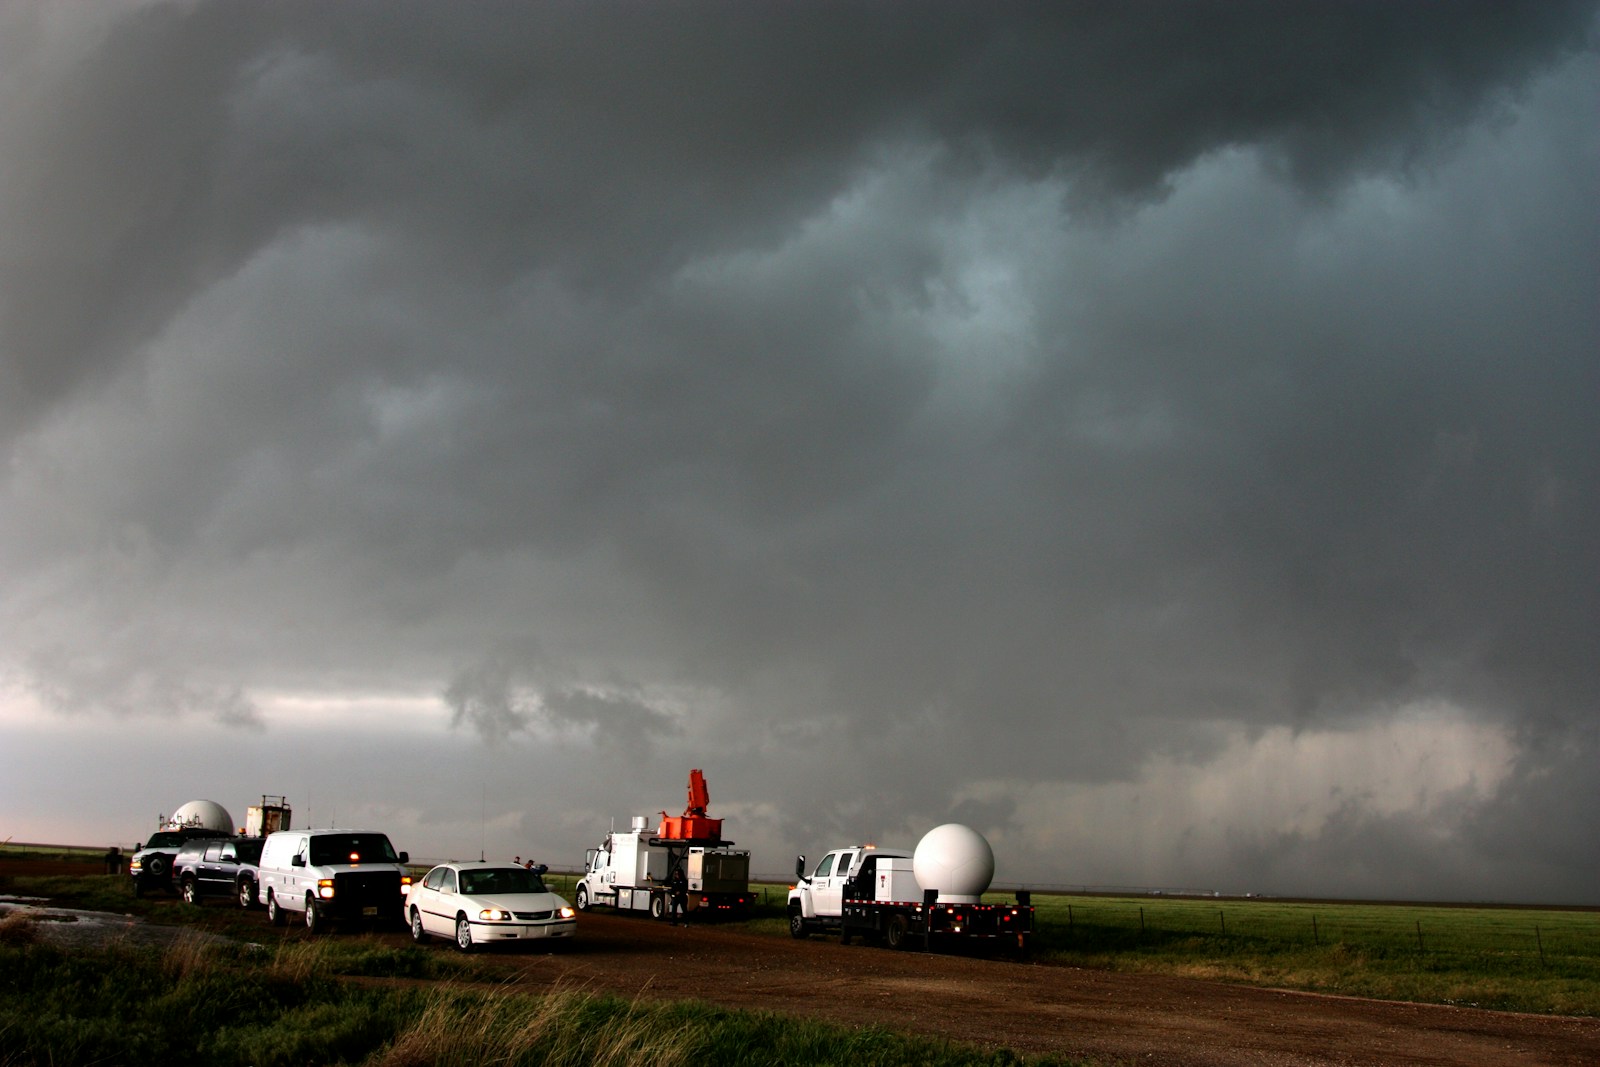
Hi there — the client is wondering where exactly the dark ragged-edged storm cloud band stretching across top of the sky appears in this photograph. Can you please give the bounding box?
[9,0,1592,426]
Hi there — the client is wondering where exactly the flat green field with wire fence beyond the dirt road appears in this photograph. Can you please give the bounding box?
[752,885,1600,1016]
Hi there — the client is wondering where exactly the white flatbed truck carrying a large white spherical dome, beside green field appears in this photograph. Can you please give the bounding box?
[789,822,1034,955]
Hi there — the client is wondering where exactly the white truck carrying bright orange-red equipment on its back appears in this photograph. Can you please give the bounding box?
[573,769,750,920]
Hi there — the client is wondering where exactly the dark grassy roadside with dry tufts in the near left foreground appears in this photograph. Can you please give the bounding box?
[0,917,1093,1067]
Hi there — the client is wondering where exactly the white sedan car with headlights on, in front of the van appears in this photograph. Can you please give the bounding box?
[405,862,578,952]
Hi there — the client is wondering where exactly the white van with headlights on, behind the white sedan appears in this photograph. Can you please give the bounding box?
[256,830,411,933]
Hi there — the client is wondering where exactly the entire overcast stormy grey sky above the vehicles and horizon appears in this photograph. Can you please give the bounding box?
[0,0,1600,904]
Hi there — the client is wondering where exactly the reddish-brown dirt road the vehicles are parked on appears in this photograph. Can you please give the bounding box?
[13,869,1600,1067]
